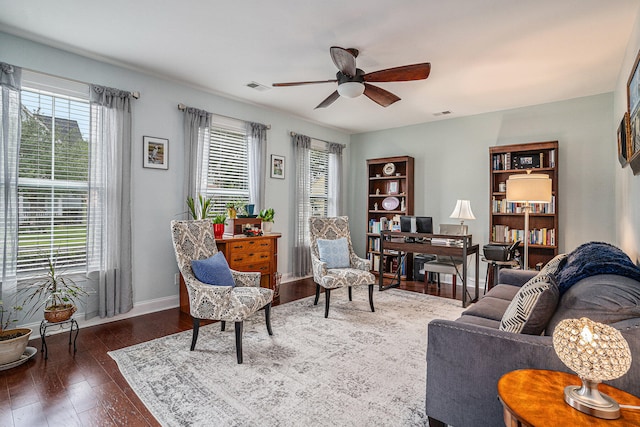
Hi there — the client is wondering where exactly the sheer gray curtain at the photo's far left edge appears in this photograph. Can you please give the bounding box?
[0,62,22,306]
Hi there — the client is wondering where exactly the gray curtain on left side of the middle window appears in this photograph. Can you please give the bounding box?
[184,107,211,201]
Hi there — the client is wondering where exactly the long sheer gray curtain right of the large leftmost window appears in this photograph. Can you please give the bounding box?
[86,85,133,318]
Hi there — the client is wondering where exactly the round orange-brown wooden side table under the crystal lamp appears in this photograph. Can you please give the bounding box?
[498,369,640,427]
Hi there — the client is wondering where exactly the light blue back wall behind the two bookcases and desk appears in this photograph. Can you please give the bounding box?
[349,93,617,278]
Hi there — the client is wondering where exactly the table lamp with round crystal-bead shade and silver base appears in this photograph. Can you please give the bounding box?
[553,317,631,420]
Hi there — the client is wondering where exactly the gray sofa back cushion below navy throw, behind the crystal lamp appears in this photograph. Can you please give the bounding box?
[545,274,640,335]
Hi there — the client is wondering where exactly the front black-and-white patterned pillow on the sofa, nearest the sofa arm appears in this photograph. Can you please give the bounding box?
[500,274,560,335]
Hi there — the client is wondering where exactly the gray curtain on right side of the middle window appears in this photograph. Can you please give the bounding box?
[247,122,267,210]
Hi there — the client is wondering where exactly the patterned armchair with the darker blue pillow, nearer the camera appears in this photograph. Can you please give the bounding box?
[171,220,273,363]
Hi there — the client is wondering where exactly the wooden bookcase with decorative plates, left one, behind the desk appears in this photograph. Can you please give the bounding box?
[366,156,414,280]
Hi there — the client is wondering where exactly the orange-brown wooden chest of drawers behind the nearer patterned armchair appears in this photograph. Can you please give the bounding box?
[180,233,281,314]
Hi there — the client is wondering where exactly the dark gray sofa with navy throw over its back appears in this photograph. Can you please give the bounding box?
[426,244,640,427]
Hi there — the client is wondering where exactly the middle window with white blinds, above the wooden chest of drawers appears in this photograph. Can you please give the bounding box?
[208,116,249,213]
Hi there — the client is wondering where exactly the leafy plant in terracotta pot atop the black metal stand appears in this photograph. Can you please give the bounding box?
[23,256,88,323]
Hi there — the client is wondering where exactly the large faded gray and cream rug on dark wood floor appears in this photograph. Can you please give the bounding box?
[109,287,462,427]
